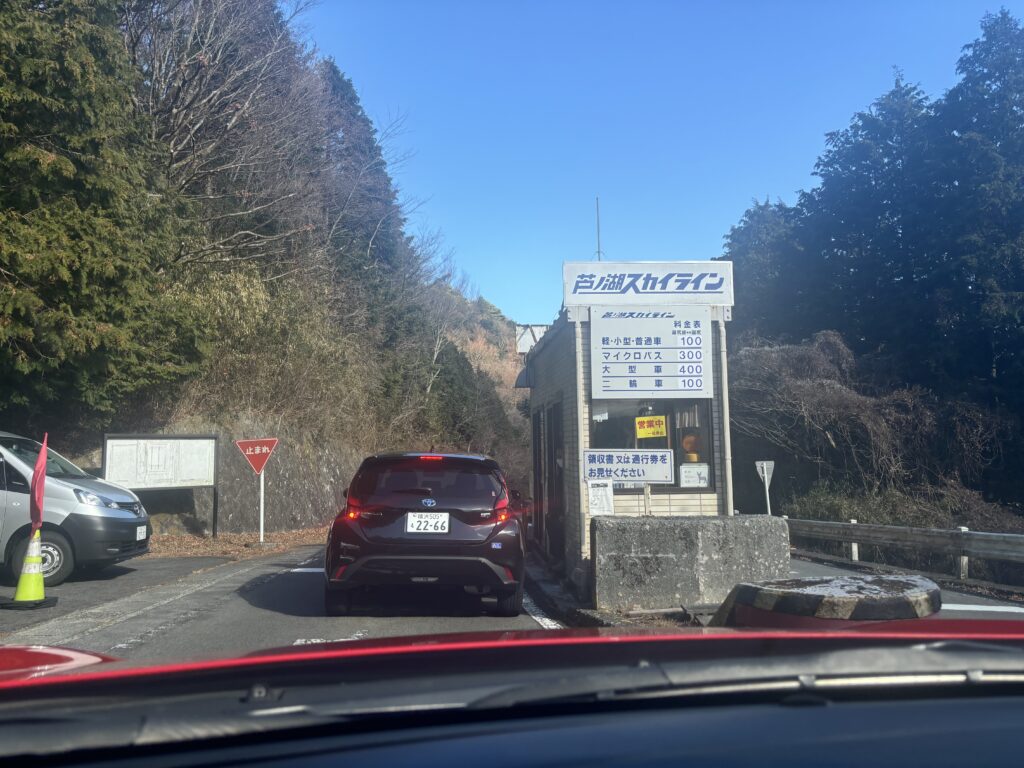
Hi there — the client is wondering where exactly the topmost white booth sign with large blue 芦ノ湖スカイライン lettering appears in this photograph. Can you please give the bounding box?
[562,261,733,306]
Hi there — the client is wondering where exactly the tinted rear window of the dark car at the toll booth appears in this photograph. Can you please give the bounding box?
[350,458,503,506]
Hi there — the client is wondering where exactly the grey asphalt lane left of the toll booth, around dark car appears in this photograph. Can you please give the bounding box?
[0,547,555,660]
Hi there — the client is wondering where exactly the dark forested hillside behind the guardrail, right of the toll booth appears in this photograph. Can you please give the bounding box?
[726,11,1024,529]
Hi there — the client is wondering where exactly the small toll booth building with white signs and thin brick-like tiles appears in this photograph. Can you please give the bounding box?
[517,261,733,592]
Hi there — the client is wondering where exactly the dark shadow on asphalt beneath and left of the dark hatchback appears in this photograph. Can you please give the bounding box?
[239,571,494,617]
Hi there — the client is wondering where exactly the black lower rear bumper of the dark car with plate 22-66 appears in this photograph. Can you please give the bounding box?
[327,555,521,591]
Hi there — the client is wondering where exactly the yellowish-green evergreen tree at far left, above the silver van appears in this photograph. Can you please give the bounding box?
[0,0,196,424]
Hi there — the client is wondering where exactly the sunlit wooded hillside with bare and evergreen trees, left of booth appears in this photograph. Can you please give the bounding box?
[0,0,526,524]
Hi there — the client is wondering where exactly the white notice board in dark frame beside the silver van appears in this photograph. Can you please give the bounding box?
[103,435,217,490]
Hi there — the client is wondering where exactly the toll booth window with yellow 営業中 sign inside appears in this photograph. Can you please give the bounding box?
[590,399,715,493]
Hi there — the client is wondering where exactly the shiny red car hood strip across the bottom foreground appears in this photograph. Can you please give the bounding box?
[6,618,1024,691]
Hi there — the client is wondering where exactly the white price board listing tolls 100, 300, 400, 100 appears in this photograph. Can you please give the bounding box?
[590,306,714,400]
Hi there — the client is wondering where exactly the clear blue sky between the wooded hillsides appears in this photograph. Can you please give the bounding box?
[303,0,1024,323]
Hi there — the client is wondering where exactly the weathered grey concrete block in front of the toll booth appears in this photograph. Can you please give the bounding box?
[590,515,790,610]
